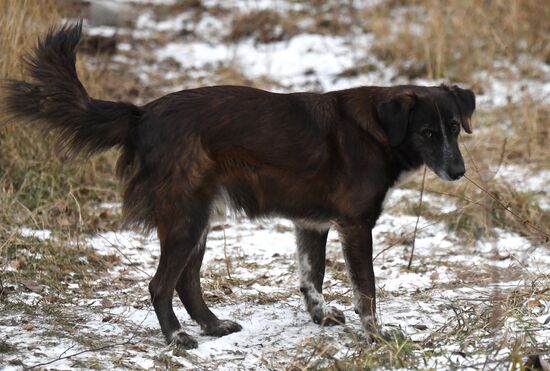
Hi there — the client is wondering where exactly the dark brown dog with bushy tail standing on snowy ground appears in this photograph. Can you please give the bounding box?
[4,23,475,349]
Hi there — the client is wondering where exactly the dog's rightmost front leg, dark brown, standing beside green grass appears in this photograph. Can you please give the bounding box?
[339,224,379,335]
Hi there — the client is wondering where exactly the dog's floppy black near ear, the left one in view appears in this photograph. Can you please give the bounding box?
[376,92,417,147]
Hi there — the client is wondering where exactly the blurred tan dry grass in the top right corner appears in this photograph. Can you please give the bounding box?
[360,0,550,82]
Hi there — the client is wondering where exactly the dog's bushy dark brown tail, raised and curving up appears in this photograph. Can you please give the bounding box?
[3,22,141,156]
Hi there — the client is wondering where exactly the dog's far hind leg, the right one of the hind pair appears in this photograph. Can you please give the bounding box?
[176,233,242,336]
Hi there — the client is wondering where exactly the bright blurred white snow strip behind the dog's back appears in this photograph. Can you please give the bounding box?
[157,34,388,90]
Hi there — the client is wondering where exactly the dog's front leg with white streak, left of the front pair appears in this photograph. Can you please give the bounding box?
[296,225,346,326]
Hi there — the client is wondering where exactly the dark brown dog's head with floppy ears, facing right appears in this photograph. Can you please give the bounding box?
[377,85,475,180]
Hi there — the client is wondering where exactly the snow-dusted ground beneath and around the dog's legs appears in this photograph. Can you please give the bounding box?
[0,185,550,370]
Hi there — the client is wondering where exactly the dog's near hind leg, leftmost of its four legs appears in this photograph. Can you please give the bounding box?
[149,205,208,349]
